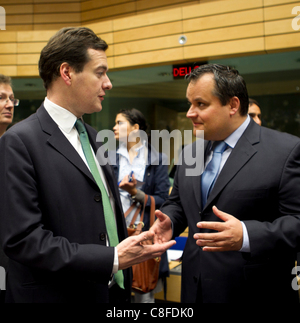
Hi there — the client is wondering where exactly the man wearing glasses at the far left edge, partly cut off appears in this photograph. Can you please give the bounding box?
[0,74,19,137]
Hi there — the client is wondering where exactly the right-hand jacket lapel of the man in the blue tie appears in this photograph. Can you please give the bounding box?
[204,120,260,213]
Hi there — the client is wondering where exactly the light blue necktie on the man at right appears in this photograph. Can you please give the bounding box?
[201,141,227,207]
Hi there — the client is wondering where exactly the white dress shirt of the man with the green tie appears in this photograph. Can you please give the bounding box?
[44,98,119,274]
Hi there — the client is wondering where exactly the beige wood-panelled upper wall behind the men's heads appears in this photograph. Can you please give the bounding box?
[0,0,300,77]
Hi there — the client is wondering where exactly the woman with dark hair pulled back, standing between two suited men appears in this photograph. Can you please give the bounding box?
[109,109,170,303]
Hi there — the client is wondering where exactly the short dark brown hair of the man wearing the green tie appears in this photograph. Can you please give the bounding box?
[39,27,108,90]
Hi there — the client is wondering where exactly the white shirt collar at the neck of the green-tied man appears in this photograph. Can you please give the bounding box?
[44,97,77,133]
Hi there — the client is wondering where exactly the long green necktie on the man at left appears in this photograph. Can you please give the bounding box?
[75,119,124,289]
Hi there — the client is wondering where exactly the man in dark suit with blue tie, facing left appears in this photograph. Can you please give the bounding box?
[152,64,300,303]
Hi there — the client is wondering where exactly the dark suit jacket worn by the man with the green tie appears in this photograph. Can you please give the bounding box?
[0,105,131,302]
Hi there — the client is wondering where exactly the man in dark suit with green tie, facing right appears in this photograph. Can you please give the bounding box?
[0,27,173,303]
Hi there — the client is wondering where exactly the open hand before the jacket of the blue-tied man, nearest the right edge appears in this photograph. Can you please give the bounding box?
[194,206,243,252]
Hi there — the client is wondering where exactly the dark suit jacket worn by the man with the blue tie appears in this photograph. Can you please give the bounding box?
[162,120,300,303]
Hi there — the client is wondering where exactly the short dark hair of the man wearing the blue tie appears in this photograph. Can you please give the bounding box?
[187,64,249,116]
